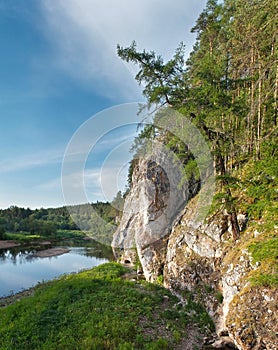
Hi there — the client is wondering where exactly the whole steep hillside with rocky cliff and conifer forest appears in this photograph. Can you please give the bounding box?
[112,0,278,350]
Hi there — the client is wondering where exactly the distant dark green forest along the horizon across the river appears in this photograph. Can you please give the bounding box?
[0,192,124,245]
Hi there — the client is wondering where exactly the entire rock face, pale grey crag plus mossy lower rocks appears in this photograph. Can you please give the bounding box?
[112,151,278,350]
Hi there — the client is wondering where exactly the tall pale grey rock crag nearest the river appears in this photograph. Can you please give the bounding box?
[112,143,192,281]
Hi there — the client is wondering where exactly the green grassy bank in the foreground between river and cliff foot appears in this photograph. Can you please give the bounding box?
[0,263,213,350]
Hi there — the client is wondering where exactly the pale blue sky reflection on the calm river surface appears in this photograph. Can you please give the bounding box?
[0,247,108,297]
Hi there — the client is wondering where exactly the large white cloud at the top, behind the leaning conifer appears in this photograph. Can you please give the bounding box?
[42,0,206,99]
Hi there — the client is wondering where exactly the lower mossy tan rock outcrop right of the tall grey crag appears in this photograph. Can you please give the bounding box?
[164,205,278,350]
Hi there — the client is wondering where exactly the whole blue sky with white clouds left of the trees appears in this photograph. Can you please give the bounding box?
[0,0,206,208]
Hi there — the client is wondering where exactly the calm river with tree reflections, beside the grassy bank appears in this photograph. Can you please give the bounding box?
[0,241,112,297]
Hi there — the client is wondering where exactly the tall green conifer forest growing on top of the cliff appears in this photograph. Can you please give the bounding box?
[117,0,278,239]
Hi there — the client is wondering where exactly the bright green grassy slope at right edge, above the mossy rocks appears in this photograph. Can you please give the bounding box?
[237,155,278,288]
